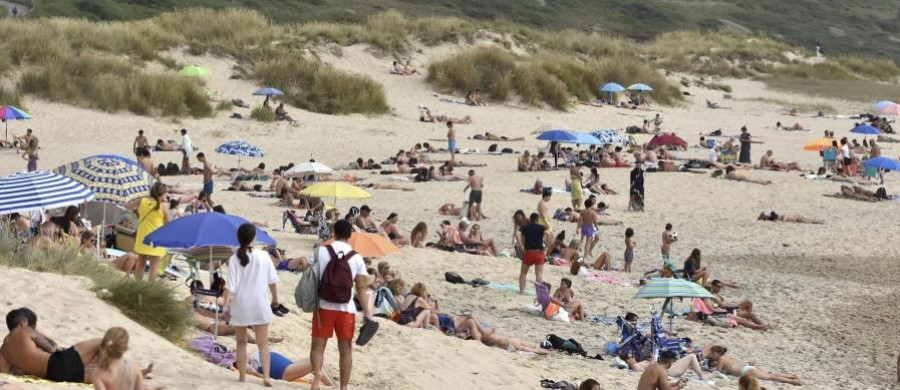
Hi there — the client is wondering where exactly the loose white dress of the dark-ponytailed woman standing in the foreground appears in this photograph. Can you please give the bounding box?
[225,250,278,326]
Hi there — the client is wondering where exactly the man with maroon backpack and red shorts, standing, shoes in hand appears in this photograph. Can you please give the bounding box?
[309,219,374,390]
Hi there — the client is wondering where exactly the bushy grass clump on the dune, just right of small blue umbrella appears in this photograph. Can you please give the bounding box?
[252,56,389,114]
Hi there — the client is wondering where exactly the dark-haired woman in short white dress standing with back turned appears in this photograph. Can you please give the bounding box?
[225,223,278,387]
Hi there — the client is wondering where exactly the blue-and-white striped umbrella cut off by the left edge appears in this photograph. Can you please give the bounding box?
[0,171,94,215]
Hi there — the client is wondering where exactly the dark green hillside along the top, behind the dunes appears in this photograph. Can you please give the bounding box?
[19,0,900,59]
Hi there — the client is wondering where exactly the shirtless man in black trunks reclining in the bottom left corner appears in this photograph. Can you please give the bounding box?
[0,307,100,383]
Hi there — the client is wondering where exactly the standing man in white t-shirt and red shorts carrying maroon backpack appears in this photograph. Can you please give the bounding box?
[309,219,374,390]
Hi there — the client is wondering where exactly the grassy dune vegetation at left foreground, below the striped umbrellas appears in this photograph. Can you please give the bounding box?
[0,236,191,342]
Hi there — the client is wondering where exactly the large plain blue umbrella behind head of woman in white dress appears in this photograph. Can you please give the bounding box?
[144,212,275,248]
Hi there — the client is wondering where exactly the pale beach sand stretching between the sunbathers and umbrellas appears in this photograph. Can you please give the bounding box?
[0,41,900,389]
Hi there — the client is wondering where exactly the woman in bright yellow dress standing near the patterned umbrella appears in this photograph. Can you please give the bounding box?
[126,181,169,282]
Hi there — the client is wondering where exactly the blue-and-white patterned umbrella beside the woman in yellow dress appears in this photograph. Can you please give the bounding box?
[53,155,151,204]
